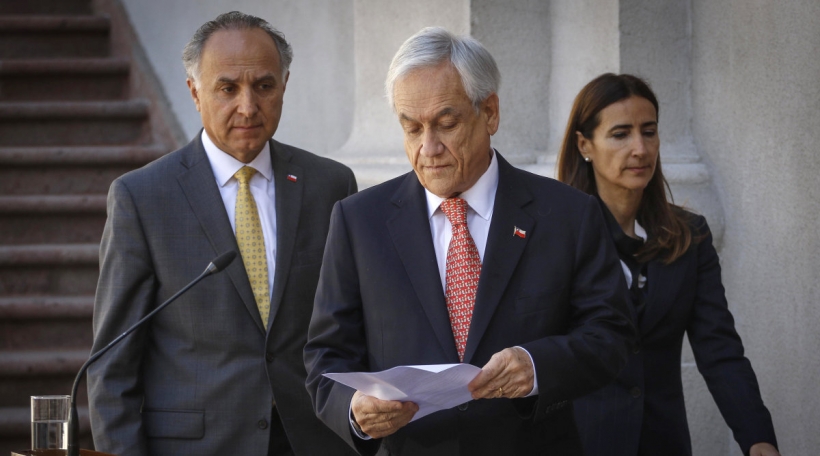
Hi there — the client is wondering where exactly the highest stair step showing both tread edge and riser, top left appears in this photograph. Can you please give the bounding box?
[0,15,111,59]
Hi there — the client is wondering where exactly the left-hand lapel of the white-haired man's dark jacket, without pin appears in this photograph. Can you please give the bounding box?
[387,172,458,363]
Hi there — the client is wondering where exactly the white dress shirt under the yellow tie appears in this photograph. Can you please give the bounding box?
[202,130,276,300]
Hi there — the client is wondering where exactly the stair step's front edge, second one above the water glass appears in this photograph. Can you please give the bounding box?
[0,295,94,320]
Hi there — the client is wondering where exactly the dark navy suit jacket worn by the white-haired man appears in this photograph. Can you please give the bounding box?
[305,155,634,456]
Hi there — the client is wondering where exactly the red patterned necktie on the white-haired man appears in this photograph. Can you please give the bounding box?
[441,198,481,362]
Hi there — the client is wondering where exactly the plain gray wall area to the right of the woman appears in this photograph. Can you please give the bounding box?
[692,0,820,455]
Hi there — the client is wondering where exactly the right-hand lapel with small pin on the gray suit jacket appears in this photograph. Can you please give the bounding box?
[268,141,304,327]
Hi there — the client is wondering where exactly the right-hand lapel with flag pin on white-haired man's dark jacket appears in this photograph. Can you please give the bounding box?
[464,157,535,363]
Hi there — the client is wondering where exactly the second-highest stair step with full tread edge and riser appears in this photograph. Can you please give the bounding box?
[0,58,130,101]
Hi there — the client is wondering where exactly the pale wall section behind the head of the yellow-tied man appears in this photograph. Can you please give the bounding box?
[121,0,354,154]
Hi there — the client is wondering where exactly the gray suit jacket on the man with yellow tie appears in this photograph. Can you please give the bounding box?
[88,135,356,456]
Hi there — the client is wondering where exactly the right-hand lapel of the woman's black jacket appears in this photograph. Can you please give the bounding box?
[640,257,686,334]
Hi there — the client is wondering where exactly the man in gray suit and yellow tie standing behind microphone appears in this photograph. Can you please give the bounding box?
[88,12,356,456]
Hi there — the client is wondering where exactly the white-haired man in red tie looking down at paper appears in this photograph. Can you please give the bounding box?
[305,28,634,455]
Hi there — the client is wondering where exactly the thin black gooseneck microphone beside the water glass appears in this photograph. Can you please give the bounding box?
[68,250,236,456]
